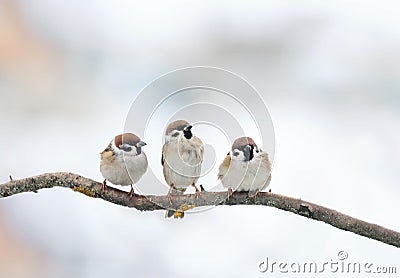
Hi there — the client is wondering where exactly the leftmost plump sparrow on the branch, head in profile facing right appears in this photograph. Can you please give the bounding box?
[100,133,148,197]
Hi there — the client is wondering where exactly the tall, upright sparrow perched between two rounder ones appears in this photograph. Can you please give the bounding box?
[161,120,204,217]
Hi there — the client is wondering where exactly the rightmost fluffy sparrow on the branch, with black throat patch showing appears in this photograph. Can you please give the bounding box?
[218,137,271,199]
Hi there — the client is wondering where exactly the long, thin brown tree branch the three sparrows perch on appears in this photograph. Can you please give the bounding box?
[0,173,400,247]
